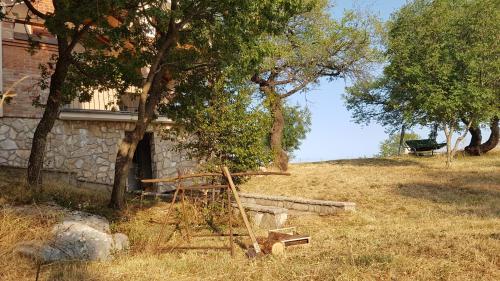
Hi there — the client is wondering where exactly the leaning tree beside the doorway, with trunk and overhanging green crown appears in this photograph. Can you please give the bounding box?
[100,0,303,209]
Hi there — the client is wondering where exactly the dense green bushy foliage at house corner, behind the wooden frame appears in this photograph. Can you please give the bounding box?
[164,78,271,171]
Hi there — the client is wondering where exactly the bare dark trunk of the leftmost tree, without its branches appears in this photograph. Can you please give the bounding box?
[28,57,70,191]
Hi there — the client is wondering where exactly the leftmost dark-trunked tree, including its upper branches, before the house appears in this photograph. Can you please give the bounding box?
[14,0,129,189]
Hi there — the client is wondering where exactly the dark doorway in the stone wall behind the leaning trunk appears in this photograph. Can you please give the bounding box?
[128,133,153,190]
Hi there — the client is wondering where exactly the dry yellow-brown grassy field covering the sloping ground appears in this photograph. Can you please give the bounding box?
[0,151,500,280]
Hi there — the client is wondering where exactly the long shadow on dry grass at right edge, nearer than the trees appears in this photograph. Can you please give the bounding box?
[396,182,500,218]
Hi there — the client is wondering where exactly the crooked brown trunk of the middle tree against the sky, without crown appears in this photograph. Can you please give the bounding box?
[268,94,288,171]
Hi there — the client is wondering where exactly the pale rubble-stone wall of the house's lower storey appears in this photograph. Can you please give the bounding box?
[0,117,194,188]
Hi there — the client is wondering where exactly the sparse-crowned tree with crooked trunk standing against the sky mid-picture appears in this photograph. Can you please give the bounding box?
[252,1,376,171]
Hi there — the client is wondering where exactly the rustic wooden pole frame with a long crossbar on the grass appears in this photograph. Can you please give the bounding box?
[142,167,290,256]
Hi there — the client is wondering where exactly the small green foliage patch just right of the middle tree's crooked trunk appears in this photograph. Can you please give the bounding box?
[282,105,311,154]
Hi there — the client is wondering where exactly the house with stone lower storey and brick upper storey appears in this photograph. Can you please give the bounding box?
[0,0,192,189]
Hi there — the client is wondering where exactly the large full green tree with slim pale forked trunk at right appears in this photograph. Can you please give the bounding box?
[351,0,499,166]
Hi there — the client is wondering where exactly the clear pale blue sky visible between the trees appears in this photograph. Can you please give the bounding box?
[288,0,454,162]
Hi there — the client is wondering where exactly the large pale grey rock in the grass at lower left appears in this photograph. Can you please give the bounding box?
[14,211,129,264]
